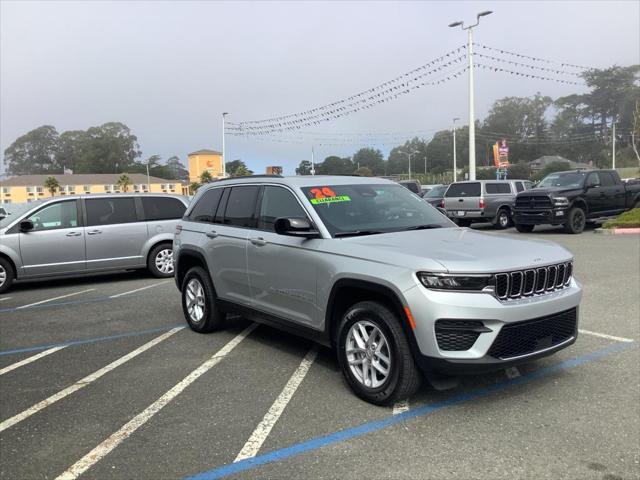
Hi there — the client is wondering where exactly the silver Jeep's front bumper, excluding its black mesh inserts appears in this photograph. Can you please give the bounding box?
[404,279,582,374]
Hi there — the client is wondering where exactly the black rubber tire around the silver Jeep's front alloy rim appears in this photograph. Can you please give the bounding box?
[337,301,422,405]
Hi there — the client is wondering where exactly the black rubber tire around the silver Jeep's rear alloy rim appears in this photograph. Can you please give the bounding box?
[182,267,227,333]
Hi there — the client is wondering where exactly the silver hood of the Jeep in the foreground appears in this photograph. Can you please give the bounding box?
[338,228,573,273]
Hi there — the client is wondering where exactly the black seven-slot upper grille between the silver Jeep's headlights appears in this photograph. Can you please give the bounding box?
[494,262,573,300]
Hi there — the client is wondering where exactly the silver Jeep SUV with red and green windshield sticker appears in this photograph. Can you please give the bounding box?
[173,176,581,404]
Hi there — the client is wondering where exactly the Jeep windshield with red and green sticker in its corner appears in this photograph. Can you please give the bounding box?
[302,184,455,237]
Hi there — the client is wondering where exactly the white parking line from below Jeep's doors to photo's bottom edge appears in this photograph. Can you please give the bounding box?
[56,323,258,480]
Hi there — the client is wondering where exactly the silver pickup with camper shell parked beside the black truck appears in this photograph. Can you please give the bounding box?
[443,180,532,228]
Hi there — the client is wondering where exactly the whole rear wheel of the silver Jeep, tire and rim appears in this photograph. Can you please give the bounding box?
[182,267,227,333]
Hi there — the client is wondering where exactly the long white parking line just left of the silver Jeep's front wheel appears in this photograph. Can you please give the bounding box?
[234,346,318,462]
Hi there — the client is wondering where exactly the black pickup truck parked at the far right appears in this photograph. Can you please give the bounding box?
[513,170,640,233]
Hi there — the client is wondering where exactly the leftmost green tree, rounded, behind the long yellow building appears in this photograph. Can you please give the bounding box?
[4,125,59,175]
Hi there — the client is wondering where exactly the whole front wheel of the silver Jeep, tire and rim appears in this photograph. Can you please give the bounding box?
[337,301,421,405]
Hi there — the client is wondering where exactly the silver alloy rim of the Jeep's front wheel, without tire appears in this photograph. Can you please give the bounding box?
[345,320,392,388]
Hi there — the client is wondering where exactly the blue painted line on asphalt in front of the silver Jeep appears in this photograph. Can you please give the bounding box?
[186,343,634,480]
